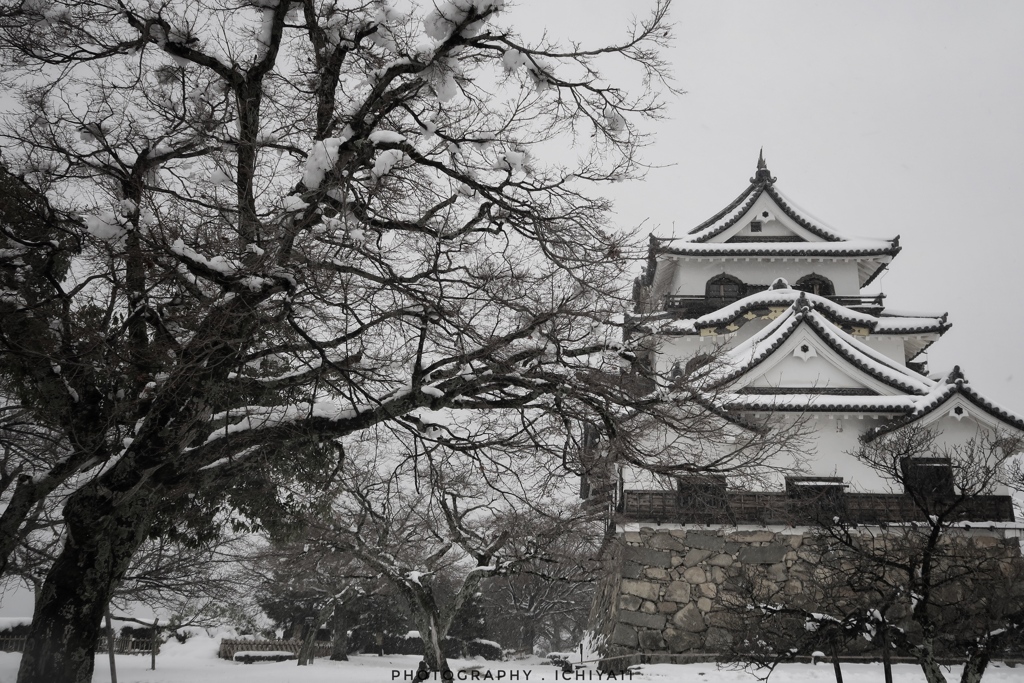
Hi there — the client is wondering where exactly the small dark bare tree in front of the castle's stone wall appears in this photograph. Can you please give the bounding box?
[744,425,1024,683]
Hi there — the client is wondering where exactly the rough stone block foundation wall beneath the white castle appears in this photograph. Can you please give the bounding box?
[591,527,1020,660]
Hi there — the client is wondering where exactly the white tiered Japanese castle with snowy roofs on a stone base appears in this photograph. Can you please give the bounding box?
[592,157,1024,655]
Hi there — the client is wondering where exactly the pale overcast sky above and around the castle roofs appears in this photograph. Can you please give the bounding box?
[524,0,1024,405]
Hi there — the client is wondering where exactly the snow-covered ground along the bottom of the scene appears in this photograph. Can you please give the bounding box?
[0,637,1024,683]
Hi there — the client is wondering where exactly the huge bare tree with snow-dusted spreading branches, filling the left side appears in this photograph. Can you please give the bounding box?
[0,0,806,682]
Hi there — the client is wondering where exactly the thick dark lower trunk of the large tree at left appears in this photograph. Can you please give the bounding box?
[17,486,155,683]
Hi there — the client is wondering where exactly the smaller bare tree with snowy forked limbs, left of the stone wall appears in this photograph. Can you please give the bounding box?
[307,428,600,672]
